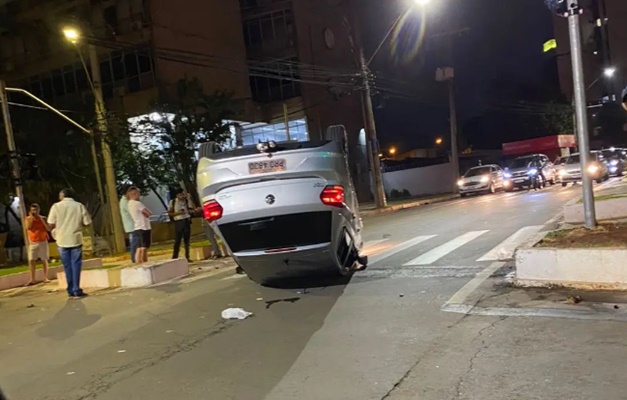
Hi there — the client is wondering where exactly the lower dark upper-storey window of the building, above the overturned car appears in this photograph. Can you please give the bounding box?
[250,58,302,103]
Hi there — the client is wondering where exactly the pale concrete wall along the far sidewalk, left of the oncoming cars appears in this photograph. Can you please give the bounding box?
[383,163,456,196]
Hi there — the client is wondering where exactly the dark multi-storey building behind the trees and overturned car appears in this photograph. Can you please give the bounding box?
[0,0,369,197]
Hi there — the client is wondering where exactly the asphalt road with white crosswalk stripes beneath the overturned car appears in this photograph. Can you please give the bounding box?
[0,182,627,400]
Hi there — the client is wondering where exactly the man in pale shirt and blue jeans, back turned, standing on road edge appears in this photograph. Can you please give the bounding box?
[48,189,91,298]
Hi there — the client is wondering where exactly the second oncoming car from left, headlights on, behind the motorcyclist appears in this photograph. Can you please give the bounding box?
[504,154,556,190]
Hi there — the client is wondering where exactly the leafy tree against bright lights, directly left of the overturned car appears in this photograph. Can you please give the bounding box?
[131,79,237,204]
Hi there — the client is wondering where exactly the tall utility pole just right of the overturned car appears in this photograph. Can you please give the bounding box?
[359,49,387,208]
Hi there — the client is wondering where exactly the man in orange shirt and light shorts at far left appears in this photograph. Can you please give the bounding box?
[26,204,50,286]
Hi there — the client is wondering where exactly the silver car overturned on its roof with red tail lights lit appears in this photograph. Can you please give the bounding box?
[197,126,367,284]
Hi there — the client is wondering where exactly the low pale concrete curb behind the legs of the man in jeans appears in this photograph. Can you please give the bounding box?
[57,258,189,289]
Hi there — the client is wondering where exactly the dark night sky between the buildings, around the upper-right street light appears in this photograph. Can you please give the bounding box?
[362,0,559,151]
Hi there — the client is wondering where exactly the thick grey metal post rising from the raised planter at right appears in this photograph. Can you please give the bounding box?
[568,0,597,229]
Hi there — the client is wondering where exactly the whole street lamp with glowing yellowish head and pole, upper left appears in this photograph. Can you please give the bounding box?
[62,26,126,252]
